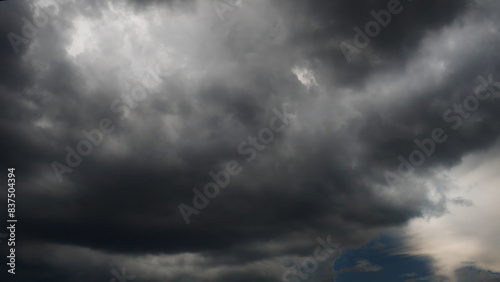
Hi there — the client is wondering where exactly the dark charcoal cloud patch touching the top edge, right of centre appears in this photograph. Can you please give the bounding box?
[268,0,470,87]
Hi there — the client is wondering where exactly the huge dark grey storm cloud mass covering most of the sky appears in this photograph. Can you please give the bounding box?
[0,1,500,281]
